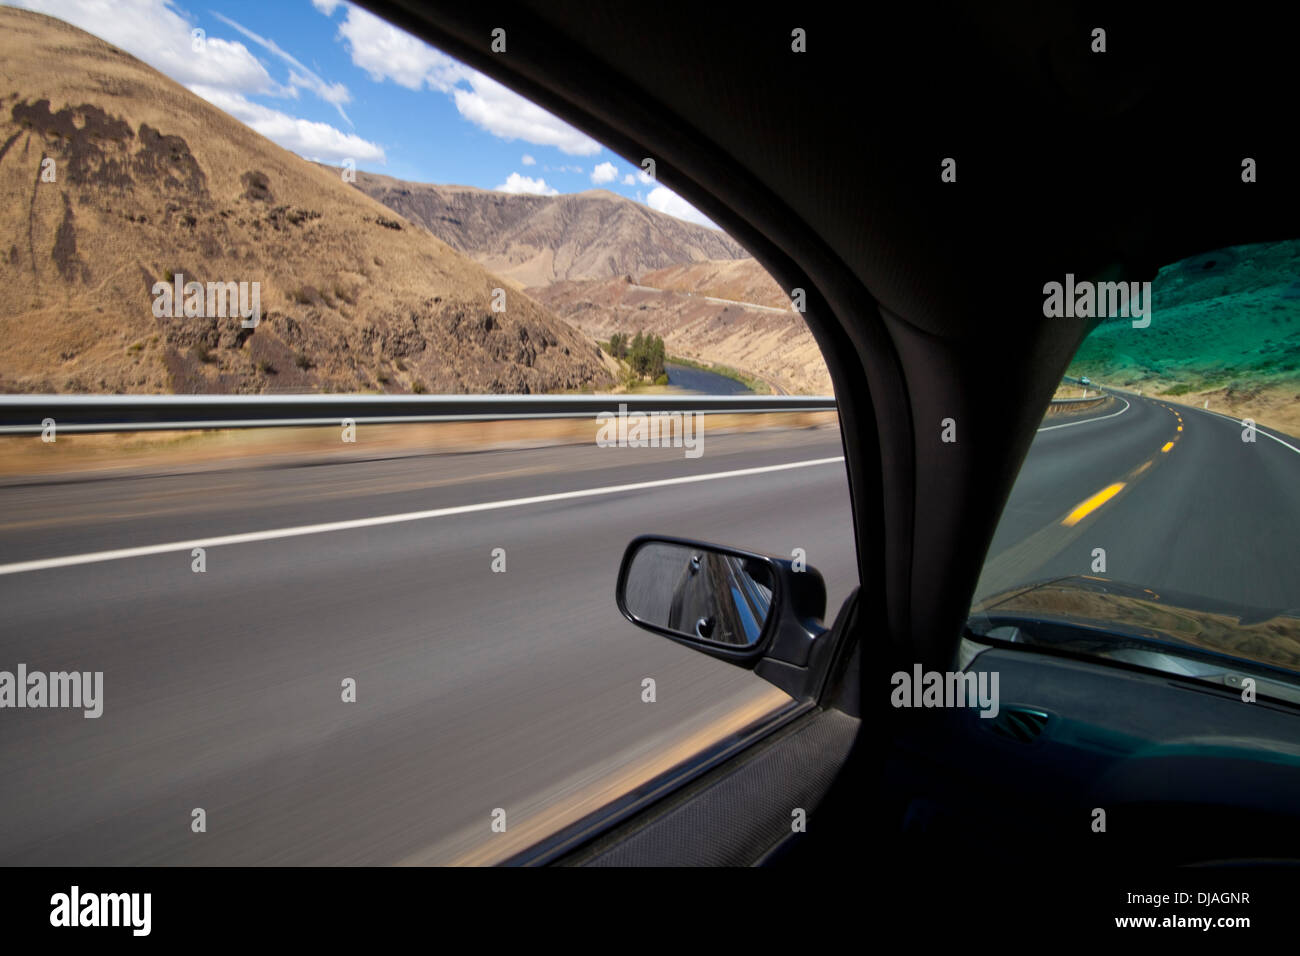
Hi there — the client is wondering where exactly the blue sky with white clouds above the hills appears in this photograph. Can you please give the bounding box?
[3,0,711,225]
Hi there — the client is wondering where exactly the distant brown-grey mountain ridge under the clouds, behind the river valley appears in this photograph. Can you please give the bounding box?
[343,172,749,287]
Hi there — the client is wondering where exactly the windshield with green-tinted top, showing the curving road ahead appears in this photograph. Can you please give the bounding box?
[970,241,1300,682]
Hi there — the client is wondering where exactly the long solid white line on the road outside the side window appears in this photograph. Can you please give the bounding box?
[0,455,844,575]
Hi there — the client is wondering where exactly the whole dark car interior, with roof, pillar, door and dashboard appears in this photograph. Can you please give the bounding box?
[348,0,1300,871]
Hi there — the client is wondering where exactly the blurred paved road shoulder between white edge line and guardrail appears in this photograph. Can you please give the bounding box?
[0,429,842,564]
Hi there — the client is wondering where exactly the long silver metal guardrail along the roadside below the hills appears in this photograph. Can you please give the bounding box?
[0,394,836,434]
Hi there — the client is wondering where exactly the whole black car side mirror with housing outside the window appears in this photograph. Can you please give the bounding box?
[616,535,826,698]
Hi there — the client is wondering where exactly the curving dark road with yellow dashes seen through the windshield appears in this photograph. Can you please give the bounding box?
[976,393,1300,609]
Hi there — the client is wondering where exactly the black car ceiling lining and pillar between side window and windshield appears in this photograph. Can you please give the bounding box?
[365,0,1300,666]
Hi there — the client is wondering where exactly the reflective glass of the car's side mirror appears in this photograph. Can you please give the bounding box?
[623,541,774,648]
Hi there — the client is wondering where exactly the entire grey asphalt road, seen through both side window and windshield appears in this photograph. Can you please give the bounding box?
[0,397,1300,865]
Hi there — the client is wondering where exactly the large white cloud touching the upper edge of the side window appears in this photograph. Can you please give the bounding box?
[330,5,601,156]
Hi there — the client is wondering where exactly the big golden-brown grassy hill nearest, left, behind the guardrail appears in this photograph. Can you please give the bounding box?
[0,8,608,393]
